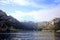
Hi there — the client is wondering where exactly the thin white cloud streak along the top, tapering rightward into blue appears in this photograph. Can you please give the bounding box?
[0,0,56,8]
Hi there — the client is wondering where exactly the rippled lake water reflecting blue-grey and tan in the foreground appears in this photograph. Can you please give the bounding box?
[0,31,59,40]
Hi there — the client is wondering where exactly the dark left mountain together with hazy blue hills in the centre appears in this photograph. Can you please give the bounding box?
[0,10,37,30]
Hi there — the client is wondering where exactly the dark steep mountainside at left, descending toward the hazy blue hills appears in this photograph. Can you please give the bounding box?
[0,10,23,30]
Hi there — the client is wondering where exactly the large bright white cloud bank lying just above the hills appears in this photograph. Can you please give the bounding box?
[10,6,60,22]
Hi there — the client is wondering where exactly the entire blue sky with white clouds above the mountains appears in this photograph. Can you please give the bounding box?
[0,0,60,22]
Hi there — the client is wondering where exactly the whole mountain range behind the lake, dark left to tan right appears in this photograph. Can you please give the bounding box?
[0,10,60,31]
